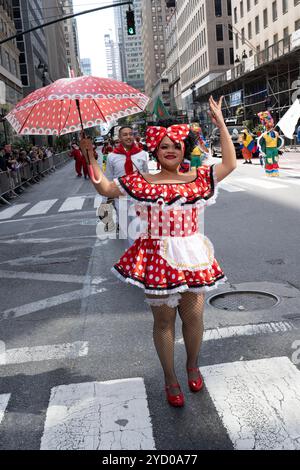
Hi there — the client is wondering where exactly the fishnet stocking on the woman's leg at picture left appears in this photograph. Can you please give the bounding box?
[147,296,179,394]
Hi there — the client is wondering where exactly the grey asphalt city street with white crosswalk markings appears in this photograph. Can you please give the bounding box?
[0,152,300,450]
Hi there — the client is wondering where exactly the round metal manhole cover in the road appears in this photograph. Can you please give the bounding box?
[208,291,280,312]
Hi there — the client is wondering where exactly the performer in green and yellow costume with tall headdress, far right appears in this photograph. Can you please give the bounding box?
[257,111,284,177]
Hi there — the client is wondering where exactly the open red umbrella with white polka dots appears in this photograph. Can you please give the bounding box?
[6,76,149,135]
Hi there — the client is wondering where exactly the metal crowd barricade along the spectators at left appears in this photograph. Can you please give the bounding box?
[0,152,70,204]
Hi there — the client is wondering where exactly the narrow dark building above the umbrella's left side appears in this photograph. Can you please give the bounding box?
[12,0,50,96]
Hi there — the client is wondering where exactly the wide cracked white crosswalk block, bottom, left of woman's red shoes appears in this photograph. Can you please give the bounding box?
[41,378,155,451]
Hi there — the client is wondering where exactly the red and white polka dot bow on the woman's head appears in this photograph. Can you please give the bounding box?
[146,124,190,152]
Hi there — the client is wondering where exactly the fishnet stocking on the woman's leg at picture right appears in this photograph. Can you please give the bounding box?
[178,292,205,380]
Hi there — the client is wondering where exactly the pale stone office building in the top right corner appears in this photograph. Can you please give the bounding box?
[232,0,300,59]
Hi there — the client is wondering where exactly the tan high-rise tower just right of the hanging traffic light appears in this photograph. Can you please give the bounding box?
[142,0,173,96]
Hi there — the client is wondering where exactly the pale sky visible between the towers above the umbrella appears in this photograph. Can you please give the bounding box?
[73,0,115,77]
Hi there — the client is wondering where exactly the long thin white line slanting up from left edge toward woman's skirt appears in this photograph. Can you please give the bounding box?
[0,286,107,320]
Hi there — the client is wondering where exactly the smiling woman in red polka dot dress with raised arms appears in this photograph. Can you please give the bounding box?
[86,97,236,407]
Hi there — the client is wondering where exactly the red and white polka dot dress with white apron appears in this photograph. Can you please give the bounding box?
[112,166,225,295]
